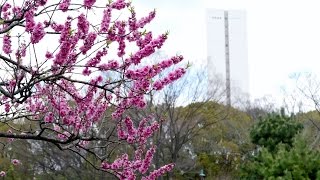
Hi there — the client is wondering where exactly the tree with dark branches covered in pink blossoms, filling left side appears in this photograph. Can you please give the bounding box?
[0,0,186,180]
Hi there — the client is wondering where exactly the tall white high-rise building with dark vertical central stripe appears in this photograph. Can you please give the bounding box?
[206,9,249,104]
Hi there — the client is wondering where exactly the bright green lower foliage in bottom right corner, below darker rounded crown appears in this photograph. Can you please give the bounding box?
[242,140,320,179]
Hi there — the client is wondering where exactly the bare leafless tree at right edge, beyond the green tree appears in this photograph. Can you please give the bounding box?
[285,73,320,148]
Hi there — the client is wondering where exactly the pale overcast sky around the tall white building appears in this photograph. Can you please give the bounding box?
[133,0,320,104]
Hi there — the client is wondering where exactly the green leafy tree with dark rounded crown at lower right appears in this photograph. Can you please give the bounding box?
[241,110,320,179]
